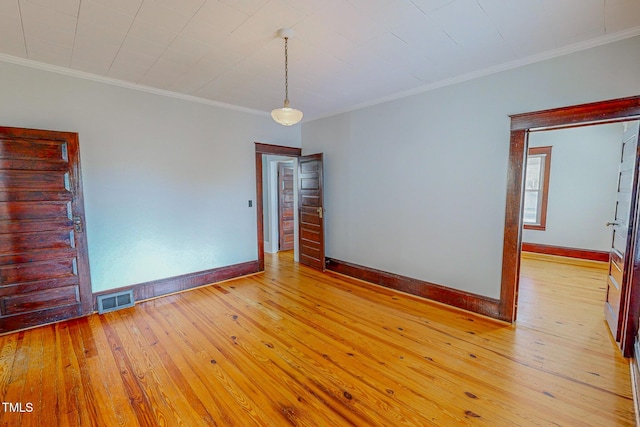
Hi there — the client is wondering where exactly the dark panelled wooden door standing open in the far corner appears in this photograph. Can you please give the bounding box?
[298,153,325,271]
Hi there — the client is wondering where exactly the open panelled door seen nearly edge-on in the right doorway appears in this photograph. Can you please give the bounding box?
[604,122,638,341]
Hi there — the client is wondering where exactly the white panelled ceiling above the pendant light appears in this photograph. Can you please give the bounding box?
[0,0,640,118]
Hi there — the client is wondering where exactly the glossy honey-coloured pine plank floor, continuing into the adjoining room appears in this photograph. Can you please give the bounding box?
[0,254,635,426]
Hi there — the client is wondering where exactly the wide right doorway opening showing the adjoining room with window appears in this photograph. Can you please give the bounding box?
[517,121,637,339]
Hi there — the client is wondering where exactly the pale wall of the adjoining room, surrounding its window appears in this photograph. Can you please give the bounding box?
[522,123,623,251]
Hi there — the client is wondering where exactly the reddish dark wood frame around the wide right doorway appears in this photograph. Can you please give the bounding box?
[499,96,640,357]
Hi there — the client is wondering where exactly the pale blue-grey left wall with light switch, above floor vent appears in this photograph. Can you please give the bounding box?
[0,62,300,292]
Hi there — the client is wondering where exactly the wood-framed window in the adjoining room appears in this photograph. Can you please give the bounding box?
[523,147,551,230]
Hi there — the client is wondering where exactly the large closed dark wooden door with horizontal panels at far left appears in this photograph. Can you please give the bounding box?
[0,127,92,333]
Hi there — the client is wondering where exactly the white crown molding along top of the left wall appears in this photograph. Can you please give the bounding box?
[0,53,269,117]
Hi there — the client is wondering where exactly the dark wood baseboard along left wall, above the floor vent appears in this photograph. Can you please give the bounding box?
[93,260,260,311]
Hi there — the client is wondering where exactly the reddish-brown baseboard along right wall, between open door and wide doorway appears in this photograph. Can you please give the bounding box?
[326,258,500,320]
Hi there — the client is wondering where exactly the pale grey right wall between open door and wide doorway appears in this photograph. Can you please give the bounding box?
[302,37,640,298]
